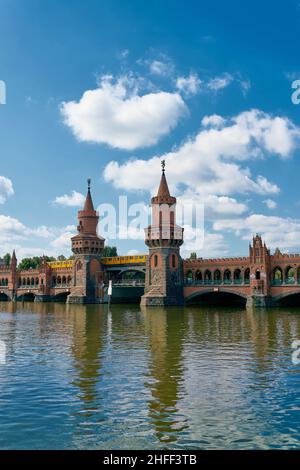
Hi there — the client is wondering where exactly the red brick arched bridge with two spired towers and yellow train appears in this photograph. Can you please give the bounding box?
[0,162,300,307]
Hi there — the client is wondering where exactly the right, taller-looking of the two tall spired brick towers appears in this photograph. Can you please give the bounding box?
[141,161,183,306]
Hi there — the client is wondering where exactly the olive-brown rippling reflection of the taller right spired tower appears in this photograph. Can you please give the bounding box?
[142,308,188,444]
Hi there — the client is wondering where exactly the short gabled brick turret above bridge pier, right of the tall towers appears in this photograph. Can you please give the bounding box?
[247,234,270,307]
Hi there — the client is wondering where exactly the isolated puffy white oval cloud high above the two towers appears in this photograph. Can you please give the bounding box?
[61,76,188,150]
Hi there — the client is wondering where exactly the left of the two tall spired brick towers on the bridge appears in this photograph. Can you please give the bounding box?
[68,179,105,303]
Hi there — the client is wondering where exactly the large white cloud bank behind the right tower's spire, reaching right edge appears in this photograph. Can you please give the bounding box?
[104,110,300,196]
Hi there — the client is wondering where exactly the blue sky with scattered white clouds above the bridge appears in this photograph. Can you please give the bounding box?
[0,0,300,258]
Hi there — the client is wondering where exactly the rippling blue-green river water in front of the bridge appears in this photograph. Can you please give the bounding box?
[0,303,300,449]
